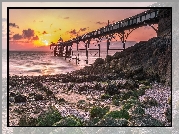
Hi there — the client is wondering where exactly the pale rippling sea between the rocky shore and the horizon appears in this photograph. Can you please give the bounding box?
[2,42,135,77]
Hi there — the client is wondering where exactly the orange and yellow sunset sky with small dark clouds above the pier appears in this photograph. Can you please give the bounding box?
[2,2,156,50]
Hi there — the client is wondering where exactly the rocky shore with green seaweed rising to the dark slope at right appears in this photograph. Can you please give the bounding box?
[9,37,171,126]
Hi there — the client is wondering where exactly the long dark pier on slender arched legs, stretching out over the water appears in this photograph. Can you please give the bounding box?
[50,9,159,64]
